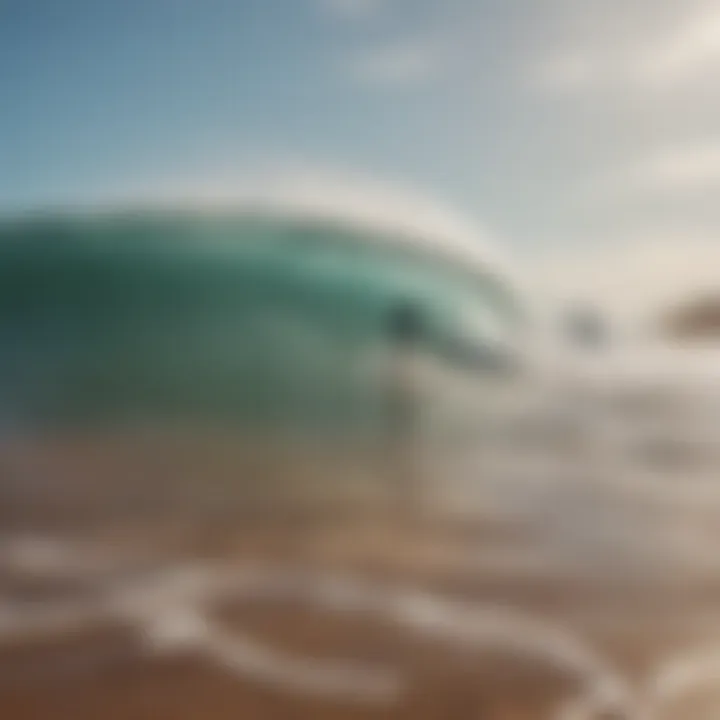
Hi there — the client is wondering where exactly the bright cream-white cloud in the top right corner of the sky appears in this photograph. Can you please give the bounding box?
[530,0,720,91]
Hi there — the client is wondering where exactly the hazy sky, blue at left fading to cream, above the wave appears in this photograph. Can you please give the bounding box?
[0,0,720,320]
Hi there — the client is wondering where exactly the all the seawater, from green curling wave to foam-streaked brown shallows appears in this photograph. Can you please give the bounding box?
[0,211,720,720]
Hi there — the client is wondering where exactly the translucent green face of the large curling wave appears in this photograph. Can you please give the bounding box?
[0,213,517,430]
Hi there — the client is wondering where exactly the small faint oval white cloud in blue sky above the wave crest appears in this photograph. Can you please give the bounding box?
[352,40,443,87]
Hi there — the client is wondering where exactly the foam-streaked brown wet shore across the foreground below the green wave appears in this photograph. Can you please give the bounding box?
[0,380,720,720]
